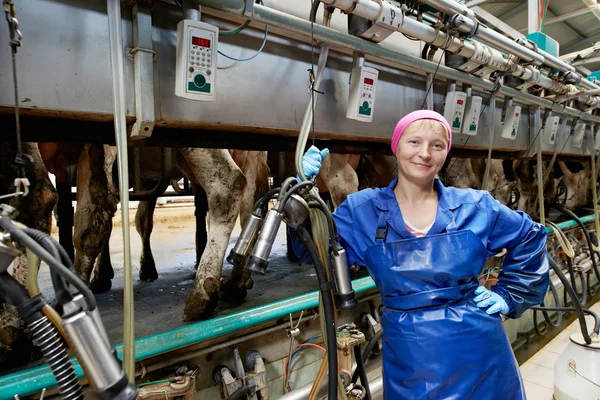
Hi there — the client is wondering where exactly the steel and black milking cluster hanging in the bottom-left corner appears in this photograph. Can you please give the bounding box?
[0,204,137,400]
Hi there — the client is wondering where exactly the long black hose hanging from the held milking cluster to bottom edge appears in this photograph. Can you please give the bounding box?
[296,226,338,400]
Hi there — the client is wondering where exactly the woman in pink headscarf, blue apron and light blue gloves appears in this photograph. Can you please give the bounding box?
[303,110,549,400]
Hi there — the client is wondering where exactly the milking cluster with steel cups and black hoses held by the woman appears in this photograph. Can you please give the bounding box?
[227,178,368,398]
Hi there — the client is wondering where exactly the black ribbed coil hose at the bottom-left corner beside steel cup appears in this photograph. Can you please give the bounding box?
[29,317,83,400]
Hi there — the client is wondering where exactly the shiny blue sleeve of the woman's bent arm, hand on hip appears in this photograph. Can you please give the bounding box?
[486,196,550,318]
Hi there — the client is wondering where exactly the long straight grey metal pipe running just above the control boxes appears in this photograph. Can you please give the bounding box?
[193,0,600,122]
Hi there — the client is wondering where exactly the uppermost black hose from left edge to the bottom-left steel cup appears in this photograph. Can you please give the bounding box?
[0,217,96,311]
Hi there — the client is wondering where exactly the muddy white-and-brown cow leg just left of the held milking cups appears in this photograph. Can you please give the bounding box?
[181,148,246,321]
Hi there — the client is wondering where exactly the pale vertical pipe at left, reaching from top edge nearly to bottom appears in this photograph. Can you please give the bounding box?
[106,0,135,382]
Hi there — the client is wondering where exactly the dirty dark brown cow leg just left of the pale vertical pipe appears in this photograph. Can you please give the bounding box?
[74,145,117,283]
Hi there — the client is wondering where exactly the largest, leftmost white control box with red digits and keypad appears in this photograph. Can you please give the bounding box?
[175,19,219,101]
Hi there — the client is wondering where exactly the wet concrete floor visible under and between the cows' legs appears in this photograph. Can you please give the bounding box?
[39,206,317,344]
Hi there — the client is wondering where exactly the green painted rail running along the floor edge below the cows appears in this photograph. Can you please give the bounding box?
[0,215,594,400]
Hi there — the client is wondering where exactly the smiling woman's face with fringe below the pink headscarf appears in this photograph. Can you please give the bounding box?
[396,120,448,184]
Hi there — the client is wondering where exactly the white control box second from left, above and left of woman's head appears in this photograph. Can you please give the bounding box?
[346,67,379,122]
